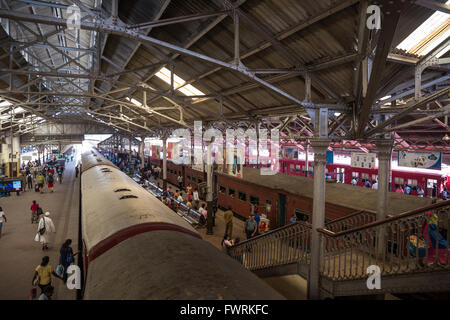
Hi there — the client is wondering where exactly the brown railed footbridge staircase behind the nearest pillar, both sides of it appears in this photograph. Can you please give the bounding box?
[229,201,450,297]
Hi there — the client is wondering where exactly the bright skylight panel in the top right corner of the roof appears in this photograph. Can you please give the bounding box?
[397,0,450,55]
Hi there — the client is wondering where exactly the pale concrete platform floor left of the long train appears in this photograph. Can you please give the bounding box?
[0,157,80,300]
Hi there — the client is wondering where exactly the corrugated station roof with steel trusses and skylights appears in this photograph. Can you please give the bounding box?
[0,0,450,152]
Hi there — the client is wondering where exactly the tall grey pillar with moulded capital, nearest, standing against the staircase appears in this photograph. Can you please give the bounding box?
[308,138,330,300]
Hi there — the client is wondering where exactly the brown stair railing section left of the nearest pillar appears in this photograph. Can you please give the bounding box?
[228,222,311,270]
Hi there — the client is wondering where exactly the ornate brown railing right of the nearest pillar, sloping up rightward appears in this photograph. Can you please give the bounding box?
[318,201,450,280]
